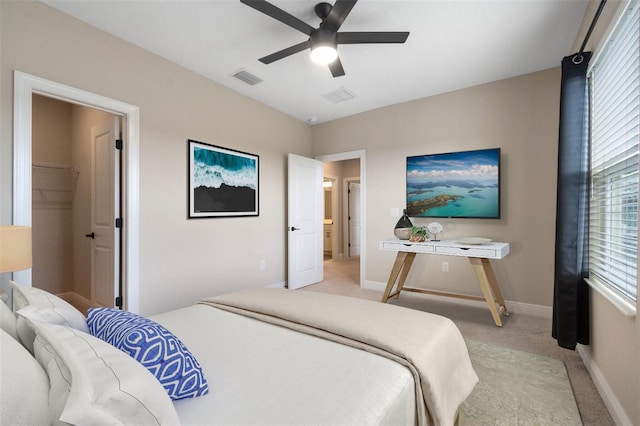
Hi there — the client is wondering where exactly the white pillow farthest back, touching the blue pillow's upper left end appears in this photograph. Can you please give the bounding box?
[9,281,89,353]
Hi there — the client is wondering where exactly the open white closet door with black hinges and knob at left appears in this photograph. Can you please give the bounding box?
[87,116,120,307]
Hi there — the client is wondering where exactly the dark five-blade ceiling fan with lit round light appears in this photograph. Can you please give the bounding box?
[240,0,409,77]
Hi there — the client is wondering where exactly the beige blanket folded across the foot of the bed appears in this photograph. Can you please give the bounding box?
[200,288,478,425]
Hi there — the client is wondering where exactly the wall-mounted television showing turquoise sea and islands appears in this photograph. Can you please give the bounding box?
[407,148,500,219]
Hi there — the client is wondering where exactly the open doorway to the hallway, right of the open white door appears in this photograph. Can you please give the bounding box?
[316,151,366,286]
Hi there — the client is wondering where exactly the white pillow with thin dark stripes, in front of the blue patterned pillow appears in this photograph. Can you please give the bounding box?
[19,309,180,425]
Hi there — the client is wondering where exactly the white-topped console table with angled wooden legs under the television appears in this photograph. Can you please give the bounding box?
[380,238,509,327]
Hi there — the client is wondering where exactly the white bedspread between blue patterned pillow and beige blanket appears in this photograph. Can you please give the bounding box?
[152,305,416,426]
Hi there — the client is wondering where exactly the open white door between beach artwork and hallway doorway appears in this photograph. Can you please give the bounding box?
[287,154,324,290]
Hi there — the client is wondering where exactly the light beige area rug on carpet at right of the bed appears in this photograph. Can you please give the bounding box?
[459,340,582,426]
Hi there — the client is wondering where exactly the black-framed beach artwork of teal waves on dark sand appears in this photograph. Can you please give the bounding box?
[188,139,260,219]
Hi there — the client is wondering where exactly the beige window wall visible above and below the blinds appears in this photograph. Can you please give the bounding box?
[573,1,640,425]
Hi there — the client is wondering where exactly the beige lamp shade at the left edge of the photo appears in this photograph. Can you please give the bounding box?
[0,225,31,272]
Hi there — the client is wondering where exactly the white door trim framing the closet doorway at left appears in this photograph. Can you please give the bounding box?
[13,70,140,313]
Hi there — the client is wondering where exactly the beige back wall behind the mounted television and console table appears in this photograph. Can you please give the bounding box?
[312,69,560,306]
